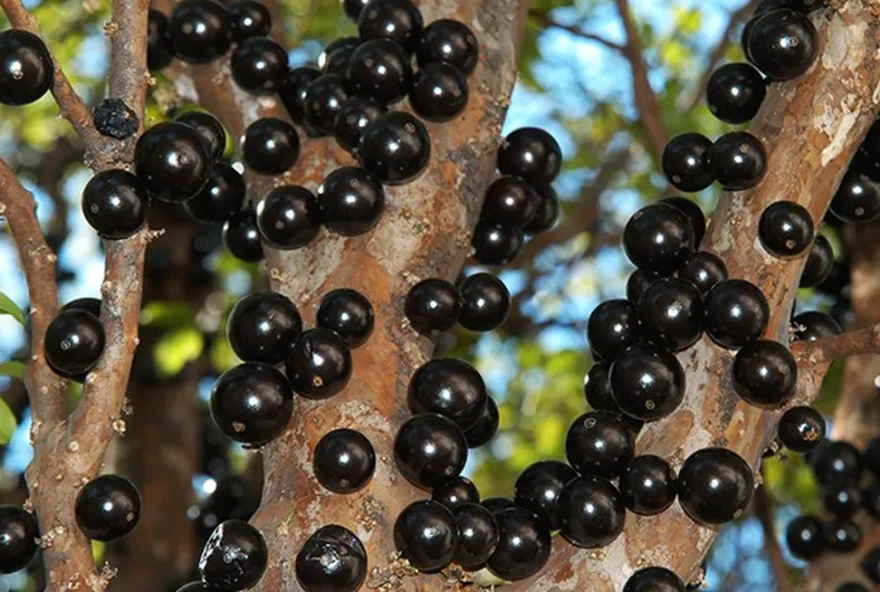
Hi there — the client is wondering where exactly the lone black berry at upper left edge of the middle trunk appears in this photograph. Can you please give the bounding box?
[241,117,299,175]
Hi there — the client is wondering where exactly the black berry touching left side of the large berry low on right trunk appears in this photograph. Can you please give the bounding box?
[618,455,678,516]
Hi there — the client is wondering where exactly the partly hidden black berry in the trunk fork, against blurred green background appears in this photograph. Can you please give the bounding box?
[513,460,577,530]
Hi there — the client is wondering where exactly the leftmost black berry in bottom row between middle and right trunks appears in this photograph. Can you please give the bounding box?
[394,500,458,572]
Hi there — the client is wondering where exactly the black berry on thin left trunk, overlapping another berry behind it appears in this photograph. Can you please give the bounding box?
[44,309,106,378]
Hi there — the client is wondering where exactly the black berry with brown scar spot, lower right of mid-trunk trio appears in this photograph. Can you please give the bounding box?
[285,327,351,399]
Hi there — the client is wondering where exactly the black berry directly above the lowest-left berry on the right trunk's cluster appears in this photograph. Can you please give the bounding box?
[565,411,636,478]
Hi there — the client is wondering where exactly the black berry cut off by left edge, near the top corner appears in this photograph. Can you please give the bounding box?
[0,29,55,106]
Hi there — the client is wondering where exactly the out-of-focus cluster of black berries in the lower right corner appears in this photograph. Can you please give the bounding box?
[785,437,880,592]
